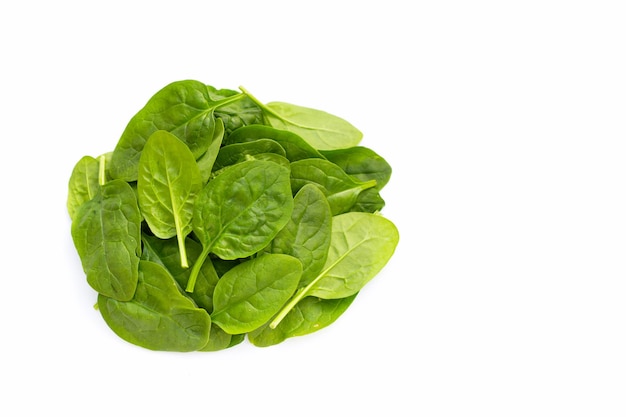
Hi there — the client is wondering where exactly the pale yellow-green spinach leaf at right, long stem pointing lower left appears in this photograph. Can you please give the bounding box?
[270,212,399,328]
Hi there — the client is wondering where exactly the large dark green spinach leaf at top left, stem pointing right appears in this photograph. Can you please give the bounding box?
[111,80,245,181]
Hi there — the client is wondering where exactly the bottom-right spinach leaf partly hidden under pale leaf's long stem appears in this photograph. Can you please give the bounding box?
[248,293,358,347]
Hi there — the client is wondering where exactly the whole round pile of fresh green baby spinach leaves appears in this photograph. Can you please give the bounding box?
[67,80,399,352]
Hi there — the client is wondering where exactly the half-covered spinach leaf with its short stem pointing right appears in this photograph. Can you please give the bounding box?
[291,159,376,215]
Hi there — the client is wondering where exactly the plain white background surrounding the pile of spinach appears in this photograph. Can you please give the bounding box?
[0,0,626,416]
